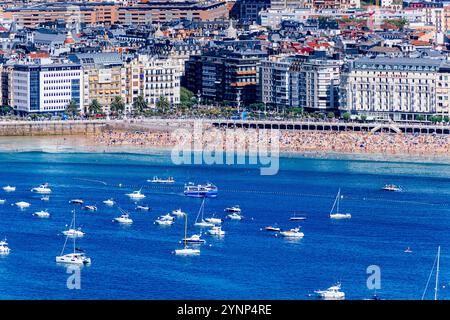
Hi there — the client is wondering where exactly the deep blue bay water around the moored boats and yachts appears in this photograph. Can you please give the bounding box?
[0,152,450,299]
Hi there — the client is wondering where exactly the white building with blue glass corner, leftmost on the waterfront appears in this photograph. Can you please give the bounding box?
[12,60,82,114]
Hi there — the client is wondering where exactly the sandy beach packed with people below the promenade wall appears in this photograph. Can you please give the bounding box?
[0,130,450,163]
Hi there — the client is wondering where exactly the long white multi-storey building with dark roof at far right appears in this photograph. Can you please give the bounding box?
[341,58,450,120]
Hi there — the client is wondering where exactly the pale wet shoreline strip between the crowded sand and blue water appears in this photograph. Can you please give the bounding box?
[0,135,450,164]
